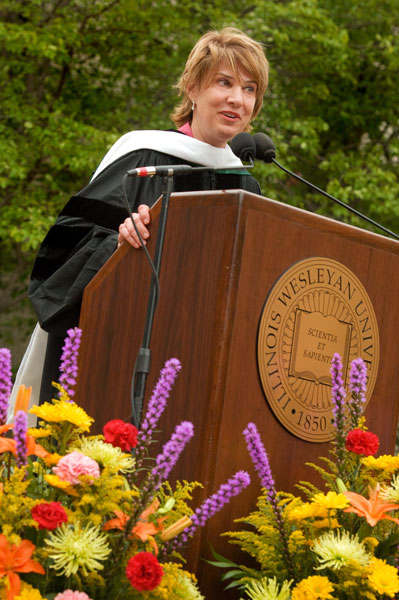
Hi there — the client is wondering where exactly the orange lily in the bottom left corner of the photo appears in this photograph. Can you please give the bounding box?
[0,534,45,600]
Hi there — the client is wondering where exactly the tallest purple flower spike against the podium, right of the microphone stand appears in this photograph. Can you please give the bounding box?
[136,358,181,442]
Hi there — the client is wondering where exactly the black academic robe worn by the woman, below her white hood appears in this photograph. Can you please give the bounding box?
[29,143,260,401]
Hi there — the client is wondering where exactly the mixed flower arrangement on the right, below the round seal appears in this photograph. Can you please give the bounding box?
[213,354,399,600]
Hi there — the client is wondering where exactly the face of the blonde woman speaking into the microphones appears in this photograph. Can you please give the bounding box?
[187,61,256,148]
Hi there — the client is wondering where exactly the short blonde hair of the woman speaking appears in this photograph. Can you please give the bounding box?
[171,27,269,131]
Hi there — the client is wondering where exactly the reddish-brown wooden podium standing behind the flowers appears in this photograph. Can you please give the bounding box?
[77,190,399,600]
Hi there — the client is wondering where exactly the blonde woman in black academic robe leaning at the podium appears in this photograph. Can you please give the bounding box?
[10,27,268,412]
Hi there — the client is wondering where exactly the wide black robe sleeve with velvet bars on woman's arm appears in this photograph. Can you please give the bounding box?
[29,150,175,334]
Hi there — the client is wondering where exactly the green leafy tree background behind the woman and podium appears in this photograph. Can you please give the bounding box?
[0,0,399,364]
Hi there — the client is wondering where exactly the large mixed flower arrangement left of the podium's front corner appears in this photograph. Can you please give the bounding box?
[0,328,253,600]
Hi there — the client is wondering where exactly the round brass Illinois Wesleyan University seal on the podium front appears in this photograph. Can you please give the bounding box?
[257,257,380,442]
